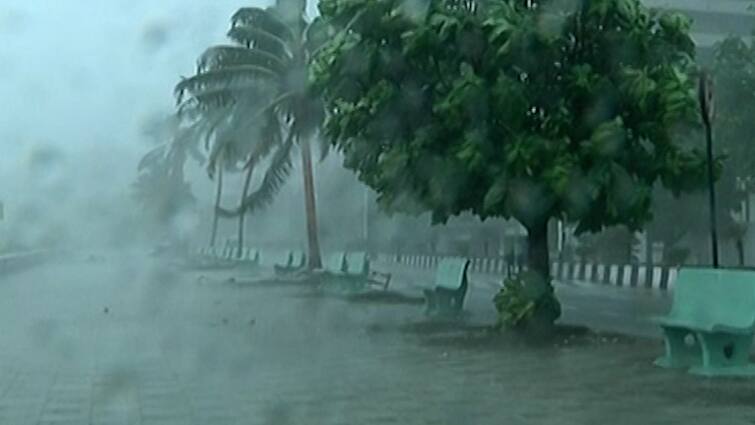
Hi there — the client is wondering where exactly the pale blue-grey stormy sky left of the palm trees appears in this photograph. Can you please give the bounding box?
[0,0,298,243]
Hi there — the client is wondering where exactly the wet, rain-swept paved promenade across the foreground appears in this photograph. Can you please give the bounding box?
[0,254,755,425]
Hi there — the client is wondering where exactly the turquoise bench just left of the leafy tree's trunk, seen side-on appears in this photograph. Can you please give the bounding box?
[423,258,469,316]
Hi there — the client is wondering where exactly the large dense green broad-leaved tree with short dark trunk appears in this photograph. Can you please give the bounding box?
[313,0,705,326]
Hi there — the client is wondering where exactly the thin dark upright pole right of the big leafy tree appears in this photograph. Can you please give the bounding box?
[698,71,718,269]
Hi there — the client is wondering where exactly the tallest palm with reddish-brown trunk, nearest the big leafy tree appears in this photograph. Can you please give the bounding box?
[176,0,327,268]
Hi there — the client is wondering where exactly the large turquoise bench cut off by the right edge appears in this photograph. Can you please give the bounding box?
[655,268,755,376]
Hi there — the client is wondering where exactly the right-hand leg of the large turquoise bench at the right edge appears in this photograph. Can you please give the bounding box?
[690,332,755,376]
